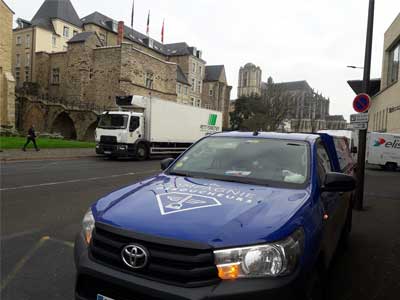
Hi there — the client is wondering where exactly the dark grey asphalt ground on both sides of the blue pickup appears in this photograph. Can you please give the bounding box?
[0,158,400,300]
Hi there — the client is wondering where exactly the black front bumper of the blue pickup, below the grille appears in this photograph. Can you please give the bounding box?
[75,234,300,300]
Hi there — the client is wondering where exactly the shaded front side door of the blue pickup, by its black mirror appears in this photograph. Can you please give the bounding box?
[317,141,347,264]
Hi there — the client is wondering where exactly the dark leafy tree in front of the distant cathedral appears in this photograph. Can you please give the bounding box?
[231,78,292,131]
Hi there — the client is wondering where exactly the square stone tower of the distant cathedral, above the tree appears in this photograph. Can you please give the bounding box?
[238,63,262,98]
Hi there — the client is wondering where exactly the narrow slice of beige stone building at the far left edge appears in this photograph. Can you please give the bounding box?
[0,0,15,128]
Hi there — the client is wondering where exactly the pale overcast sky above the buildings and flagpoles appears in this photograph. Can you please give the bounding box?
[5,0,400,118]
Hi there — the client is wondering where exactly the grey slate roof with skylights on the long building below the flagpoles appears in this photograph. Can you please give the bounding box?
[81,11,200,56]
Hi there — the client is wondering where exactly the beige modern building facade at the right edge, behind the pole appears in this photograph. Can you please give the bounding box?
[368,14,400,133]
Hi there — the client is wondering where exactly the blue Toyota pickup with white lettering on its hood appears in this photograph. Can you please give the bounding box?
[75,132,355,300]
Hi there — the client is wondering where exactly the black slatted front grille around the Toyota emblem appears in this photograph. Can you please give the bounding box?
[90,223,219,287]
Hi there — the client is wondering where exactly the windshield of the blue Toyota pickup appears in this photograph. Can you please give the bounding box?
[168,137,309,187]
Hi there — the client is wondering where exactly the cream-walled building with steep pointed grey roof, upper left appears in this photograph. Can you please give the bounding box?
[12,0,82,87]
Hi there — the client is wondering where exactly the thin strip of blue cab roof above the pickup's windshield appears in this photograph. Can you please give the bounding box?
[213,131,320,141]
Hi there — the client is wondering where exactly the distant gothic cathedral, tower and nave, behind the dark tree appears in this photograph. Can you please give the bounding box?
[238,63,346,132]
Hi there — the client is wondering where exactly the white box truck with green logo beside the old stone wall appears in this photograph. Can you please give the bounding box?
[96,96,222,160]
